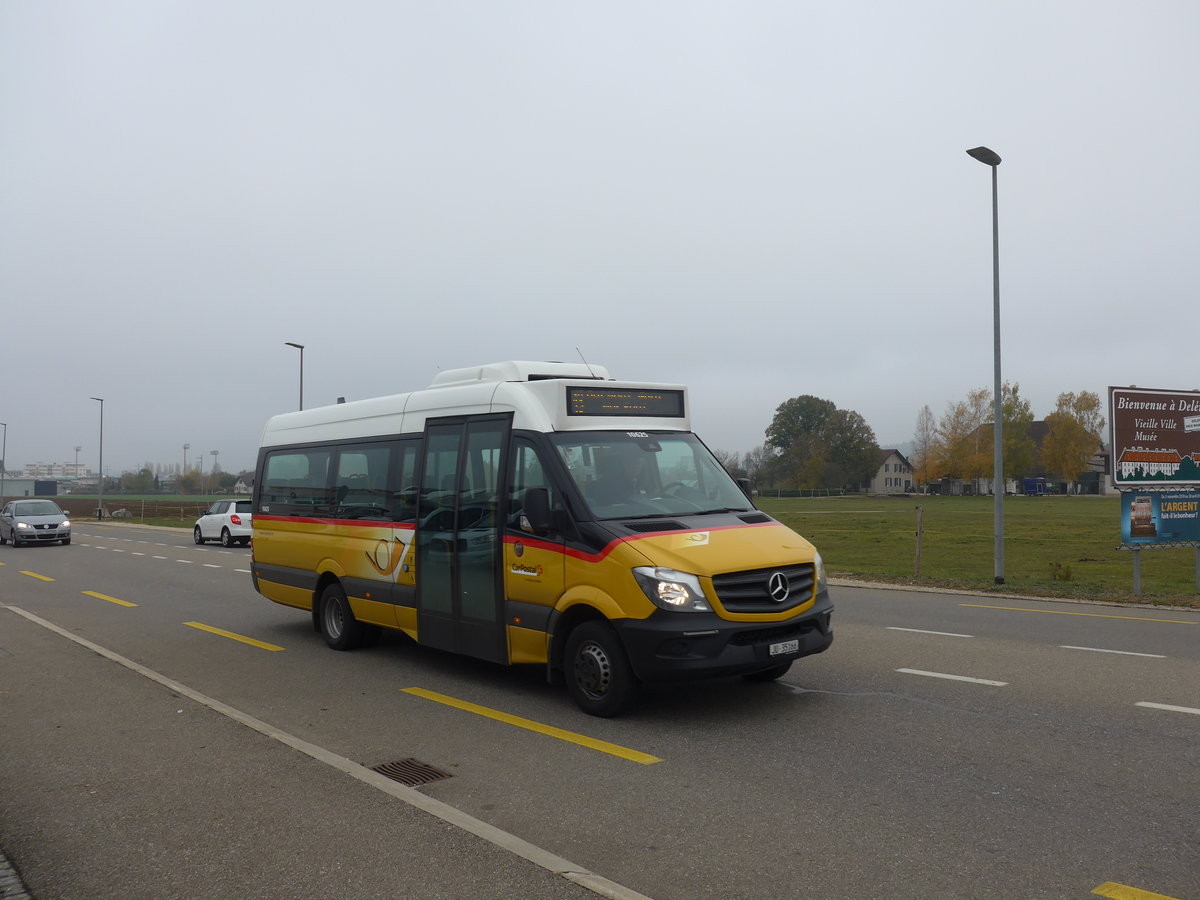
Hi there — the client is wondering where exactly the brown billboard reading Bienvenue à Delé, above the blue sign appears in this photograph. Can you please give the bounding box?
[1109,388,1200,488]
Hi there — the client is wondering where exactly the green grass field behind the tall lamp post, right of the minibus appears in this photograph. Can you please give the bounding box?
[758,497,1200,608]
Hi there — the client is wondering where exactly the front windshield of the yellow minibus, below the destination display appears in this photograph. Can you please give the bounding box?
[551,431,754,520]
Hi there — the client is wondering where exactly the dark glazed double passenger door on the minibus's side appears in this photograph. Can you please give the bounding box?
[416,415,511,662]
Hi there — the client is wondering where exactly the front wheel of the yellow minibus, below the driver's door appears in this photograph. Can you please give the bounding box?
[563,619,641,719]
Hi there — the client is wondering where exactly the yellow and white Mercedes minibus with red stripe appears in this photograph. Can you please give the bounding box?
[252,361,833,716]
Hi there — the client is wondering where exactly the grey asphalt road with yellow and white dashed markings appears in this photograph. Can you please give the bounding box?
[0,522,1200,900]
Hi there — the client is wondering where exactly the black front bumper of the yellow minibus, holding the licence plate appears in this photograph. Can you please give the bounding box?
[612,590,833,682]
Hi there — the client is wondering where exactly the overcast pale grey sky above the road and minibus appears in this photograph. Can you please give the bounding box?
[0,0,1200,474]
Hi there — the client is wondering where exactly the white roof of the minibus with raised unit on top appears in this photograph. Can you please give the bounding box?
[262,361,691,446]
